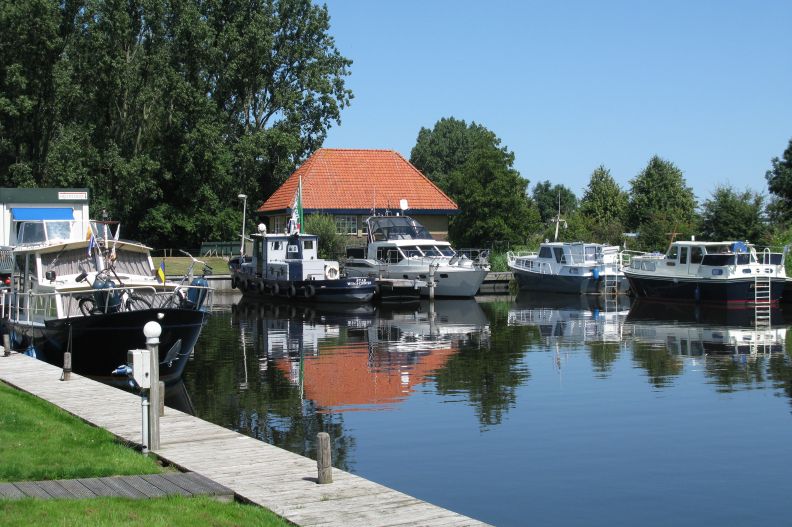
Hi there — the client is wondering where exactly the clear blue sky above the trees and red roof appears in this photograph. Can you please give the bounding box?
[320,0,792,201]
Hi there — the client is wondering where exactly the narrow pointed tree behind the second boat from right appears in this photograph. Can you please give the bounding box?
[580,165,628,244]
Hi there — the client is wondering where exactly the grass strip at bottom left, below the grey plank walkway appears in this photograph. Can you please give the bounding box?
[0,496,291,527]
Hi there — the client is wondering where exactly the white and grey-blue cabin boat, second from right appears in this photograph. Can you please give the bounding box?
[506,242,628,295]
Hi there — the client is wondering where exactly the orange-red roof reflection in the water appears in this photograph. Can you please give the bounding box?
[277,342,456,411]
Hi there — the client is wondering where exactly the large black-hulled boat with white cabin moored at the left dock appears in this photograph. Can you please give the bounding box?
[3,220,211,384]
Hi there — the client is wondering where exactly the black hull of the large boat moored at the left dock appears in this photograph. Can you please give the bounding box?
[6,309,206,384]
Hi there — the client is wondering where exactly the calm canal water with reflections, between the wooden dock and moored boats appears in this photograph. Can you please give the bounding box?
[179,295,792,526]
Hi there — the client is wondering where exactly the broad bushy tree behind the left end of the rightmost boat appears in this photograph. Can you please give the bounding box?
[627,156,696,251]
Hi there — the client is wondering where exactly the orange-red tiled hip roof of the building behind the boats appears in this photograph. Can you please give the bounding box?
[258,148,458,214]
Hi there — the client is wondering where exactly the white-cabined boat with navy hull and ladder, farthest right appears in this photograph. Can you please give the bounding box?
[624,240,786,305]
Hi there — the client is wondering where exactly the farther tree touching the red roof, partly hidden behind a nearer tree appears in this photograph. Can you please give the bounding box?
[410,117,514,191]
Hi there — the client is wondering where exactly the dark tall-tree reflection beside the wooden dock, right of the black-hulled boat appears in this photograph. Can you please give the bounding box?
[184,311,355,470]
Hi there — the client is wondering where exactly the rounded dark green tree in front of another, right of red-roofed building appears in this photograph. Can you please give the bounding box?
[448,142,539,247]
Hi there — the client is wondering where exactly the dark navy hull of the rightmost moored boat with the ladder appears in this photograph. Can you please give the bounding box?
[627,275,784,304]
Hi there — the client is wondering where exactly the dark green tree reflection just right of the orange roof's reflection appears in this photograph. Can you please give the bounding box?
[435,303,540,427]
